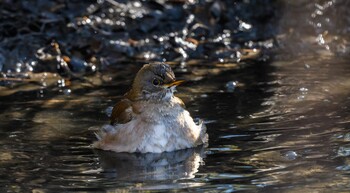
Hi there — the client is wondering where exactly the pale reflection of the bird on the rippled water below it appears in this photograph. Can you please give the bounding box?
[96,146,205,181]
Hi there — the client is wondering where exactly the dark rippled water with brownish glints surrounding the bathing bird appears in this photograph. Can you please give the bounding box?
[0,1,350,192]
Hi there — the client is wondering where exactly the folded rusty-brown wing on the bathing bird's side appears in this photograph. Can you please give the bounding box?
[111,99,132,125]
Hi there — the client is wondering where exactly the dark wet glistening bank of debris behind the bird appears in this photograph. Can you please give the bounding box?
[0,0,284,74]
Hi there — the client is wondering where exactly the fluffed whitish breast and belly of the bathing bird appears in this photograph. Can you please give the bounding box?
[111,98,200,152]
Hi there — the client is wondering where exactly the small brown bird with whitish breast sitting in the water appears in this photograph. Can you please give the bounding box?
[93,62,208,153]
